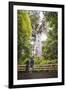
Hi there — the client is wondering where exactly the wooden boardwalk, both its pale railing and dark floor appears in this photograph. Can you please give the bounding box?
[18,64,58,80]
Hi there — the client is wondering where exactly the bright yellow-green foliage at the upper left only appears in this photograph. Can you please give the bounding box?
[17,11,32,39]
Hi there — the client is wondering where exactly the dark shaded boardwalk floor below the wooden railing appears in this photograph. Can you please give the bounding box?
[18,71,58,80]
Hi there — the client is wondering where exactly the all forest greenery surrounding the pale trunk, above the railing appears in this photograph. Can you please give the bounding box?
[17,10,58,64]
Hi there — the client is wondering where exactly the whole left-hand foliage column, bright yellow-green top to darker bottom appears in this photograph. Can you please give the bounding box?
[17,10,32,64]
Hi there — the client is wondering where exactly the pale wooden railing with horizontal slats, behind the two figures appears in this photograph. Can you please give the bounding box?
[17,64,58,71]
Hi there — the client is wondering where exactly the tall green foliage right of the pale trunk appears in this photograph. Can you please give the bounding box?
[43,12,58,60]
